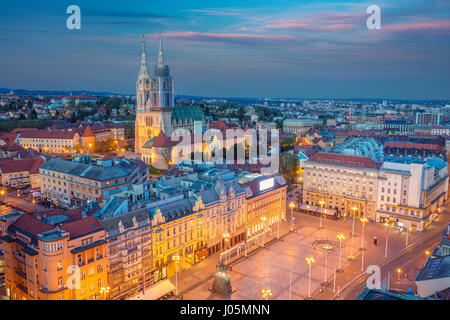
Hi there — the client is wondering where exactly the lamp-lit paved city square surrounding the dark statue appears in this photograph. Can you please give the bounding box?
[171,198,448,300]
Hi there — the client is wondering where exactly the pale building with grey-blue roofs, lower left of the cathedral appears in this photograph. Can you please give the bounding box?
[39,155,148,207]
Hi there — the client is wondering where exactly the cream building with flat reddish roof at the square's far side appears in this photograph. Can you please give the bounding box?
[303,152,379,220]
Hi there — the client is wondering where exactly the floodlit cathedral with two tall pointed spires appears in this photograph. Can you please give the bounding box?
[135,36,204,167]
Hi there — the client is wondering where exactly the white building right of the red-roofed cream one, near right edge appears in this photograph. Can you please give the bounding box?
[376,157,448,231]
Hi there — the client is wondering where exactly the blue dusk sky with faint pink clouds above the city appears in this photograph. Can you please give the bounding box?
[0,0,450,99]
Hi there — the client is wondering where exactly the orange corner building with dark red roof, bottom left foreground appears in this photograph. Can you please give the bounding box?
[0,209,108,300]
